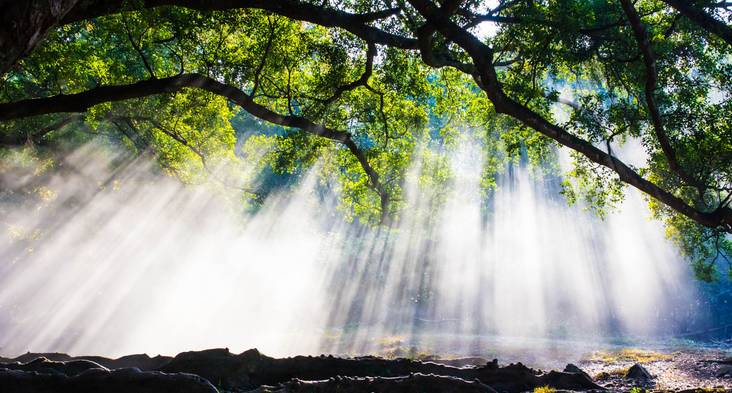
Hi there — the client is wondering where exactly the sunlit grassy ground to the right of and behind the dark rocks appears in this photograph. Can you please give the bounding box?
[338,336,732,391]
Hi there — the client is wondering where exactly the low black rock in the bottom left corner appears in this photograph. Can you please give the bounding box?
[0,368,218,393]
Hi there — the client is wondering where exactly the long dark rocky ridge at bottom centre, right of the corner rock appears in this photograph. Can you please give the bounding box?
[160,349,602,393]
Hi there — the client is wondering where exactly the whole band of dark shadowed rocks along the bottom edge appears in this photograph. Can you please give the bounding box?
[0,349,602,393]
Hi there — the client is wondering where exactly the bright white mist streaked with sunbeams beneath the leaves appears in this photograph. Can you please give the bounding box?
[0,139,705,362]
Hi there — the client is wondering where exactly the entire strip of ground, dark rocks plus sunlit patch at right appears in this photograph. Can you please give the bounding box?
[0,349,732,393]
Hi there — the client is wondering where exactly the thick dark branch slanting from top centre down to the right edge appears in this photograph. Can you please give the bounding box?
[409,0,732,233]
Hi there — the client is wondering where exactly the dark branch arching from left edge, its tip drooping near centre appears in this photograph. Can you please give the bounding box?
[0,74,388,220]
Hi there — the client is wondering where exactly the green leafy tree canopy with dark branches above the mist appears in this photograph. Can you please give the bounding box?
[0,0,732,279]
